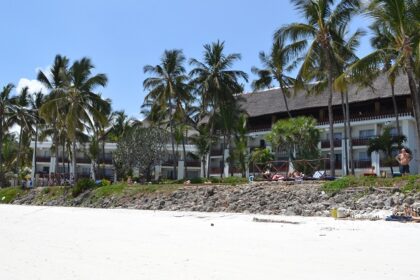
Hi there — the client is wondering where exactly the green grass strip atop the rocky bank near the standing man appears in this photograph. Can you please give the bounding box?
[323,175,420,193]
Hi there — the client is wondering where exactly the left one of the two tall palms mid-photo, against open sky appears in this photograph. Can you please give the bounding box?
[142,50,188,176]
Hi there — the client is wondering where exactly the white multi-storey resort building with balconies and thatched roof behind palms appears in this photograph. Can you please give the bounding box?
[31,76,419,179]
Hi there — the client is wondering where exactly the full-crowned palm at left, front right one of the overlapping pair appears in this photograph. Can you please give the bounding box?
[41,57,110,181]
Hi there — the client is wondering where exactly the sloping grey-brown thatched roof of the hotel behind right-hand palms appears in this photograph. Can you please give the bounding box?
[240,75,410,117]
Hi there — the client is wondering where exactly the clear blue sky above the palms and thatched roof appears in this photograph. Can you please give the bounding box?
[0,0,370,117]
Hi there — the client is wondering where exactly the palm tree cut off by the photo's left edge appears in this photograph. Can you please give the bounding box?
[0,84,14,187]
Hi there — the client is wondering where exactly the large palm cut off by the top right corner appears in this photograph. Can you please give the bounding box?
[350,0,420,155]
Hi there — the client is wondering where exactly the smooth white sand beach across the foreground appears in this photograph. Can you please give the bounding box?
[0,205,420,280]
